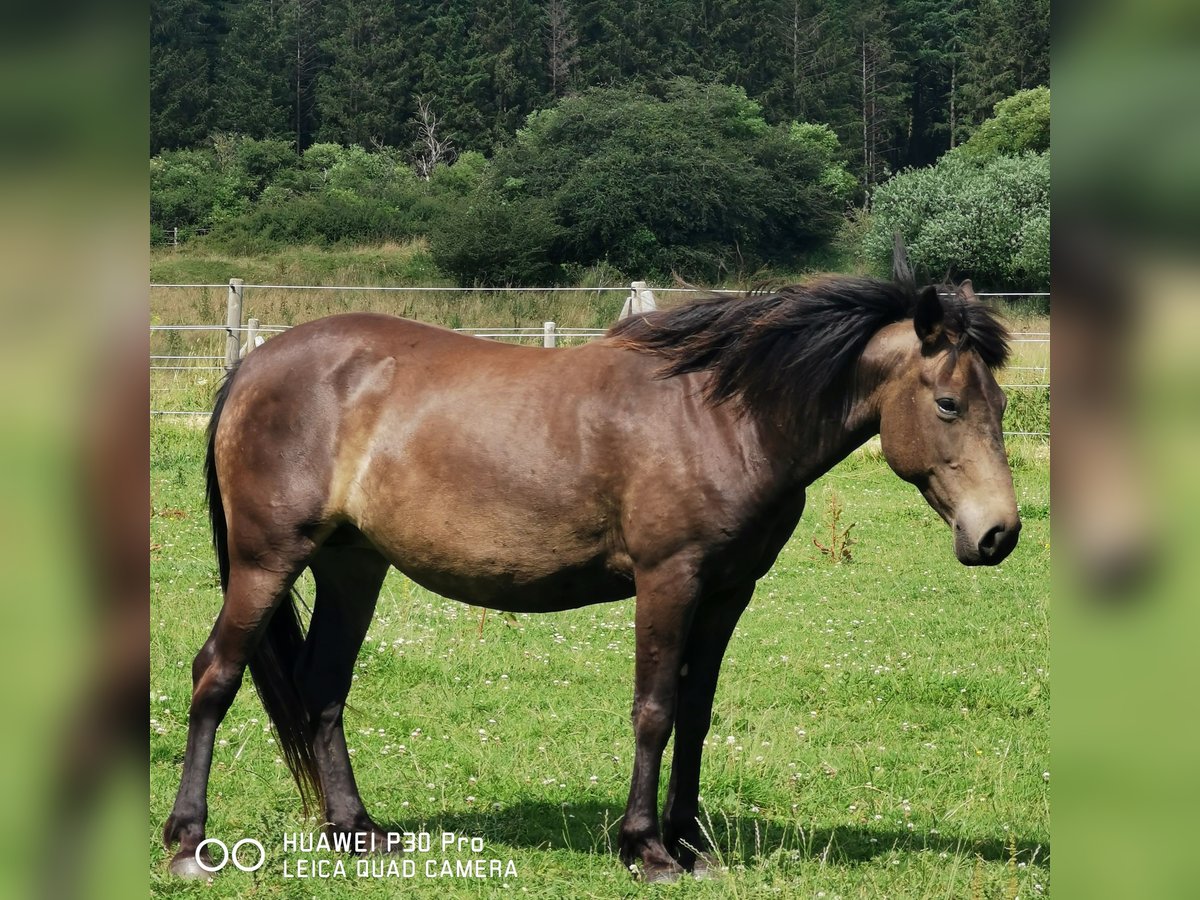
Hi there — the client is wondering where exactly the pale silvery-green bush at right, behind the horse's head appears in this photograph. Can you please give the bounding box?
[863,151,1050,290]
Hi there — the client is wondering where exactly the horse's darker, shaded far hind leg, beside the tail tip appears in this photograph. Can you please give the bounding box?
[296,546,388,841]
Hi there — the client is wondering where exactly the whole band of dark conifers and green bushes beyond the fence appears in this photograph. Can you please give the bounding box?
[150,0,1050,288]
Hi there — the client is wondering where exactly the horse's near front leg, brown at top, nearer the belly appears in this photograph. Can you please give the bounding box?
[619,563,698,882]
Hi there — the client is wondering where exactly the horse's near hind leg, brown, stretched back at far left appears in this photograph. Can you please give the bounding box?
[162,564,302,877]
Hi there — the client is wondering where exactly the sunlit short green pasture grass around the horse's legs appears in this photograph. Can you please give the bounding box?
[148,422,1050,898]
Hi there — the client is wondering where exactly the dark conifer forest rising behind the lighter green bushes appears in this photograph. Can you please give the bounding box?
[150,0,1050,187]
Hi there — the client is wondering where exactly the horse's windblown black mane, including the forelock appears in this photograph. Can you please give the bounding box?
[607,277,1008,421]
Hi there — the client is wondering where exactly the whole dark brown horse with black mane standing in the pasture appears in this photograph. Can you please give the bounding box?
[163,278,1020,881]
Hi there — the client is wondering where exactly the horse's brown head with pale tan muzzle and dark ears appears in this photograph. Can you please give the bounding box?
[880,282,1021,565]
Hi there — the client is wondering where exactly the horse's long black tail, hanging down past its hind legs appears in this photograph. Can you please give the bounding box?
[204,365,324,815]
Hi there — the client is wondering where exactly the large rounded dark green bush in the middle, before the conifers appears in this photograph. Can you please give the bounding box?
[432,79,854,283]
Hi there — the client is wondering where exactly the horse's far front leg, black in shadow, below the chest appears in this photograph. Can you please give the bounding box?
[662,582,754,877]
